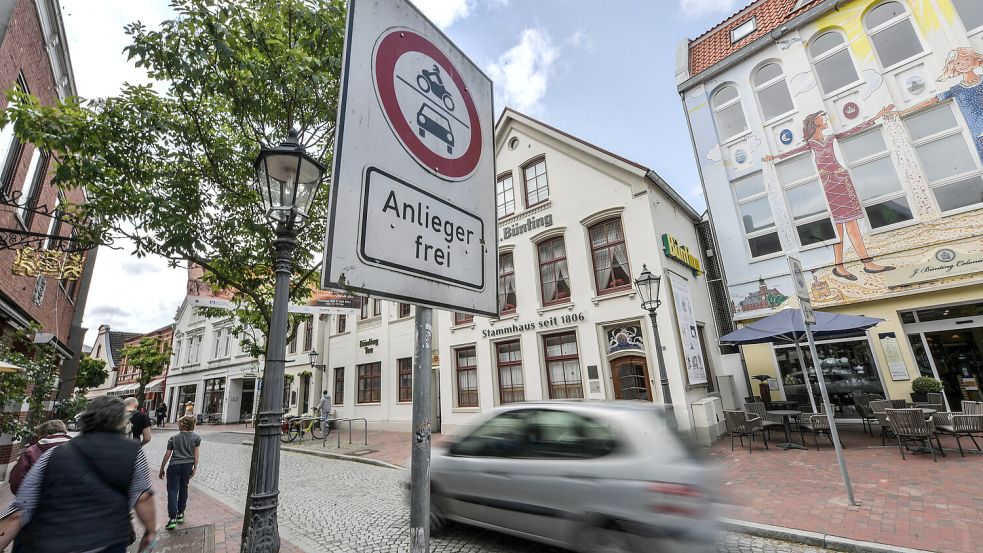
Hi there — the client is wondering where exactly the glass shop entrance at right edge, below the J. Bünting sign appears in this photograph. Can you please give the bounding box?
[901,302,983,404]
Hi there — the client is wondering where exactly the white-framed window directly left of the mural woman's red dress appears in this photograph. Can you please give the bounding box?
[775,152,836,246]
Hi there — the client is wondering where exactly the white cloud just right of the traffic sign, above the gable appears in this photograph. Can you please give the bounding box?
[488,28,560,115]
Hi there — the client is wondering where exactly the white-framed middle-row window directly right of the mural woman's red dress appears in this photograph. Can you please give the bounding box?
[840,127,914,229]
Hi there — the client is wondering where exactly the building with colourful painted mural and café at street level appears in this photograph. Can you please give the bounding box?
[677,0,983,417]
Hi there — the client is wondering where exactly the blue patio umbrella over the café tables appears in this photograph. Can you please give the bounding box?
[720,308,884,412]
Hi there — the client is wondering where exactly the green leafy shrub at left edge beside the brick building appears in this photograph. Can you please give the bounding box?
[0,325,58,438]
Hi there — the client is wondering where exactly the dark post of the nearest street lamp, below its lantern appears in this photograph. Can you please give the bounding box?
[240,223,297,553]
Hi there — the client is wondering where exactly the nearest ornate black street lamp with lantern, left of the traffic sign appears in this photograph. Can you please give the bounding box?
[241,130,324,553]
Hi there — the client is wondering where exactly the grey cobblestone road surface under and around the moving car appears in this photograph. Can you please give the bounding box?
[146,429,823,553]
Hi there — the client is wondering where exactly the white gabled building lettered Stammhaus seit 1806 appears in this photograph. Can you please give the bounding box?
[430,109,740,430]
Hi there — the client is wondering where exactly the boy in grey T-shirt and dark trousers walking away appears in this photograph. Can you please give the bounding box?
[159,416,201,530]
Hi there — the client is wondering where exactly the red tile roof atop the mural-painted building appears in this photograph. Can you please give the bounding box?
[689,0,822,77]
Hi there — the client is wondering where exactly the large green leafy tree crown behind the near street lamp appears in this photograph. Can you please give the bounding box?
[0,0,344,352]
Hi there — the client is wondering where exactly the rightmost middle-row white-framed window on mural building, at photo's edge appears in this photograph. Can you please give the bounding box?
[904,103,983,213]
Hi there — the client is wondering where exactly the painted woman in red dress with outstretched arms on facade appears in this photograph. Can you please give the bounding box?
[762,104,894,280]
